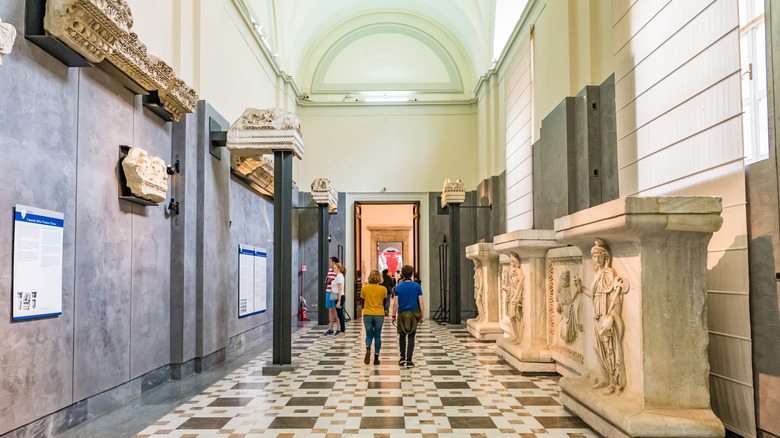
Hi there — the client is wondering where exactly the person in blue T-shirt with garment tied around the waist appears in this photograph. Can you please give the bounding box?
[390,265,425,368]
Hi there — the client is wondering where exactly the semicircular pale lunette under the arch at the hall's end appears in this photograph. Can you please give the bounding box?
[311,23,463,94]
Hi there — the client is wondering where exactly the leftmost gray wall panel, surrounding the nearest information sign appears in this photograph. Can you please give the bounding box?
[0,1,78,435]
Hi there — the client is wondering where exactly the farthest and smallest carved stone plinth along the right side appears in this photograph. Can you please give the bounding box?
[466,243,504,341]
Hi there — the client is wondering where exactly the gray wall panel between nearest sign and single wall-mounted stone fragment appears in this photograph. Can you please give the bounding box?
[73,69,134,401]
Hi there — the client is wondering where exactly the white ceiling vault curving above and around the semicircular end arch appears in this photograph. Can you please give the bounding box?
[244,0,495,97]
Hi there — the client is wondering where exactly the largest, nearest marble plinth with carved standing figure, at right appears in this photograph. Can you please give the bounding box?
[555,197,725,437]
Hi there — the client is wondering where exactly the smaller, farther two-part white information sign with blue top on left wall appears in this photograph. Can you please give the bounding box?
[238,245,268,318]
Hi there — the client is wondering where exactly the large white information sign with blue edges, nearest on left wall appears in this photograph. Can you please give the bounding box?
[12,205,65,320]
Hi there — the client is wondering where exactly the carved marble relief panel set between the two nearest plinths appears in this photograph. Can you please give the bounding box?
[547,246,580,376]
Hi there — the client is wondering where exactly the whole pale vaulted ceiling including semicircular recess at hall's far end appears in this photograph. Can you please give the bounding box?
[245,0,496,101]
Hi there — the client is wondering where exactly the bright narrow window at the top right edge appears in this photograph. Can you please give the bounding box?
[739,0,769,164]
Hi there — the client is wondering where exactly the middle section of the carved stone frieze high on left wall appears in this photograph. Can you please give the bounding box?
[106,32,175,91]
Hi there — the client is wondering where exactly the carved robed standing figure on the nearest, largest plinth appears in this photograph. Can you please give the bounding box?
[575,239,630,394]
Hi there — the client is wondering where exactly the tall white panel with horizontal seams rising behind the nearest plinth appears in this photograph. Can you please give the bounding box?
[614,0,756,436]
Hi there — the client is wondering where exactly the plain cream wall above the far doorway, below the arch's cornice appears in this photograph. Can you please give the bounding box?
[295,104,478,193]
